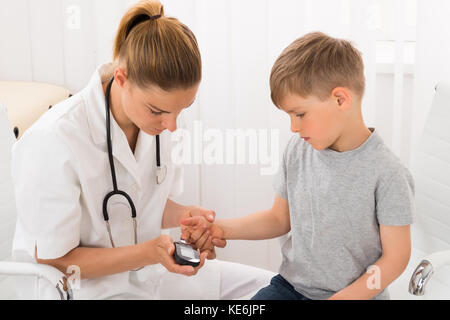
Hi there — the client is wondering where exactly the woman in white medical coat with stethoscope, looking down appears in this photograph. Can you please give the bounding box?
[12,0,272,299]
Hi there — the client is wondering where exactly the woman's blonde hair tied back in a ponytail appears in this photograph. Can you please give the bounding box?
[113,0,202,91]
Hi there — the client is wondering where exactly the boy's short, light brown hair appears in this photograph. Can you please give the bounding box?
[270,32,365,106]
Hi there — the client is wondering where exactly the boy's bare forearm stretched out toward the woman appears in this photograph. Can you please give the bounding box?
[213,195,291,244]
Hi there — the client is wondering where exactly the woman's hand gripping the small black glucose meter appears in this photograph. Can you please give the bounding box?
[149,235,208,276]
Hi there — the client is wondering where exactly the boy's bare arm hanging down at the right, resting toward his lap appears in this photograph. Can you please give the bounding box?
[329,225,411,300]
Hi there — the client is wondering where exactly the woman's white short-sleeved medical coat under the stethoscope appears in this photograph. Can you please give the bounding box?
[8,64,274,299]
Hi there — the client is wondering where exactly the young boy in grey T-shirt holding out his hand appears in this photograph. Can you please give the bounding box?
[182,32,414,299]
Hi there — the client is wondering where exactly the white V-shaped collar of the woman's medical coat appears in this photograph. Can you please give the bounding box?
[83,63,155,188]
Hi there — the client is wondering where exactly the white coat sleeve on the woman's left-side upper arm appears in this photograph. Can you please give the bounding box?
[12,129,81,259]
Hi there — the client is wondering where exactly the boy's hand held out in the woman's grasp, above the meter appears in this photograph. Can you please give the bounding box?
[181,216,226,259]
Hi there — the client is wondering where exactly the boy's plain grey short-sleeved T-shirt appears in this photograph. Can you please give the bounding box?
[274,129,414,299]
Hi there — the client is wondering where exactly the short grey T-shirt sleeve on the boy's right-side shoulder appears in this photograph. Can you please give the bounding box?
[376,167,415,226]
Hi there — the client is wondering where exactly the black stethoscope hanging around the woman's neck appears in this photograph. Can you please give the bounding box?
[103,77,167,248]
